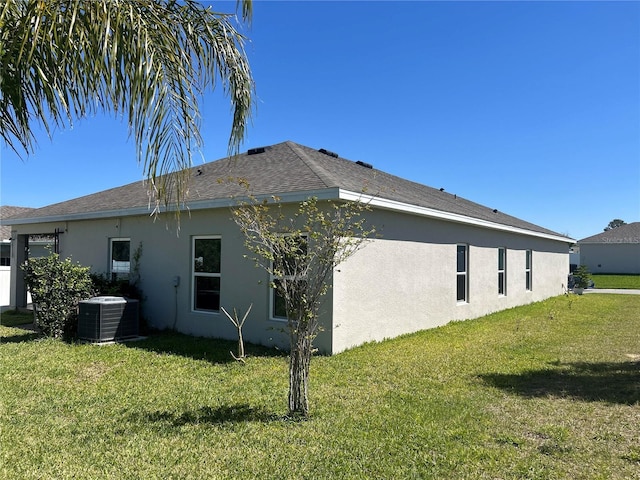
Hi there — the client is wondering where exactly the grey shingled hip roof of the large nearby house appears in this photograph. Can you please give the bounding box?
[2,141,573,243]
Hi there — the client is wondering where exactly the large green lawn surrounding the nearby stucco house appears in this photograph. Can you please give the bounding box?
[0,295,640,479]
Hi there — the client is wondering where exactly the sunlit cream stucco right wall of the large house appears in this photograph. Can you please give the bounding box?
[332,212,569,353]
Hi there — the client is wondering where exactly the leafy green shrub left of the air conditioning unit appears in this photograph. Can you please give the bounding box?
[22,253,93,338]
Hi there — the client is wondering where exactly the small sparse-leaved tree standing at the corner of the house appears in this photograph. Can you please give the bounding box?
[231,197,375,417]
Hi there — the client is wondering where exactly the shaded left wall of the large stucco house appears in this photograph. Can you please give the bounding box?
[11,209,331,352]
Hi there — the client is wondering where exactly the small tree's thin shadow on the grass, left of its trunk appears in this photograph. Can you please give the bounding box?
[135,404,284,427]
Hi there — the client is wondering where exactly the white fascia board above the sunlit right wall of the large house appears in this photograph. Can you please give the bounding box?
[340,190,575,244]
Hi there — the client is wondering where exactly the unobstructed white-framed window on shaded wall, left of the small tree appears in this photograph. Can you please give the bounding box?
[191,236,222,312]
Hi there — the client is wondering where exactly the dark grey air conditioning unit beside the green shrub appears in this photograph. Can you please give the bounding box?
[78,297,138,342]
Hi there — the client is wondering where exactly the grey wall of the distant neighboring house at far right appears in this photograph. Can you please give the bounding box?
[580,243,640,274]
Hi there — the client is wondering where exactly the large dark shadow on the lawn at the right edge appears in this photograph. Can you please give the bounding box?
[479,362,640,405]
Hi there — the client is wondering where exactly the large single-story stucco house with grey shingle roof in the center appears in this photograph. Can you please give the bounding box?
[3,141,575,354]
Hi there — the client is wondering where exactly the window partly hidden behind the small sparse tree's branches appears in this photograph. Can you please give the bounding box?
[270,235,307,320]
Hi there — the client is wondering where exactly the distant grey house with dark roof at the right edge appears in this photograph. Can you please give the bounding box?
[578,222,640,274]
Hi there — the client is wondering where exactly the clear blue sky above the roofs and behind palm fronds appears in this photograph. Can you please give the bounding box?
[0,0,640,239]
